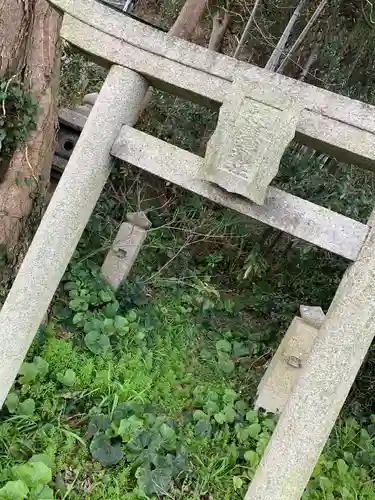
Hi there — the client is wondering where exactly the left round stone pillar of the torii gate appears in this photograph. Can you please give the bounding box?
[0,66,148,407]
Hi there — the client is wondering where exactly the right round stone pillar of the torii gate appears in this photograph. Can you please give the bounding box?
[245,216,375,500]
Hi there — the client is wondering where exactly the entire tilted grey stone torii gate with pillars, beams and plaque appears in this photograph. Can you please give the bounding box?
[0,0,375,500]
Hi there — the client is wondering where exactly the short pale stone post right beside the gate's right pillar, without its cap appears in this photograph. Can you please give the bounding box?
[255,318,318,413]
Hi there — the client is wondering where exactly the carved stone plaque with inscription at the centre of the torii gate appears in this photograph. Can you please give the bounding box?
[202,73,302,205]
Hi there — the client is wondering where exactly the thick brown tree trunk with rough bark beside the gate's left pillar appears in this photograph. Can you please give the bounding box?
[0,0,61,276]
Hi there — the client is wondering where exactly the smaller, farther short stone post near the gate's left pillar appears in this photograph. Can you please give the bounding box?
[102,221,147,291]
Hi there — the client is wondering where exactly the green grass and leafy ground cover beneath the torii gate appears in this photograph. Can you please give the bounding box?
[0,256,375,500]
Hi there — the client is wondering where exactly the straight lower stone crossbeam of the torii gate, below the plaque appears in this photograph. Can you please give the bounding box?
[112,126,369,260]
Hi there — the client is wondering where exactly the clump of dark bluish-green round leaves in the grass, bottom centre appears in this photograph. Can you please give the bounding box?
[87,401,186,495]
